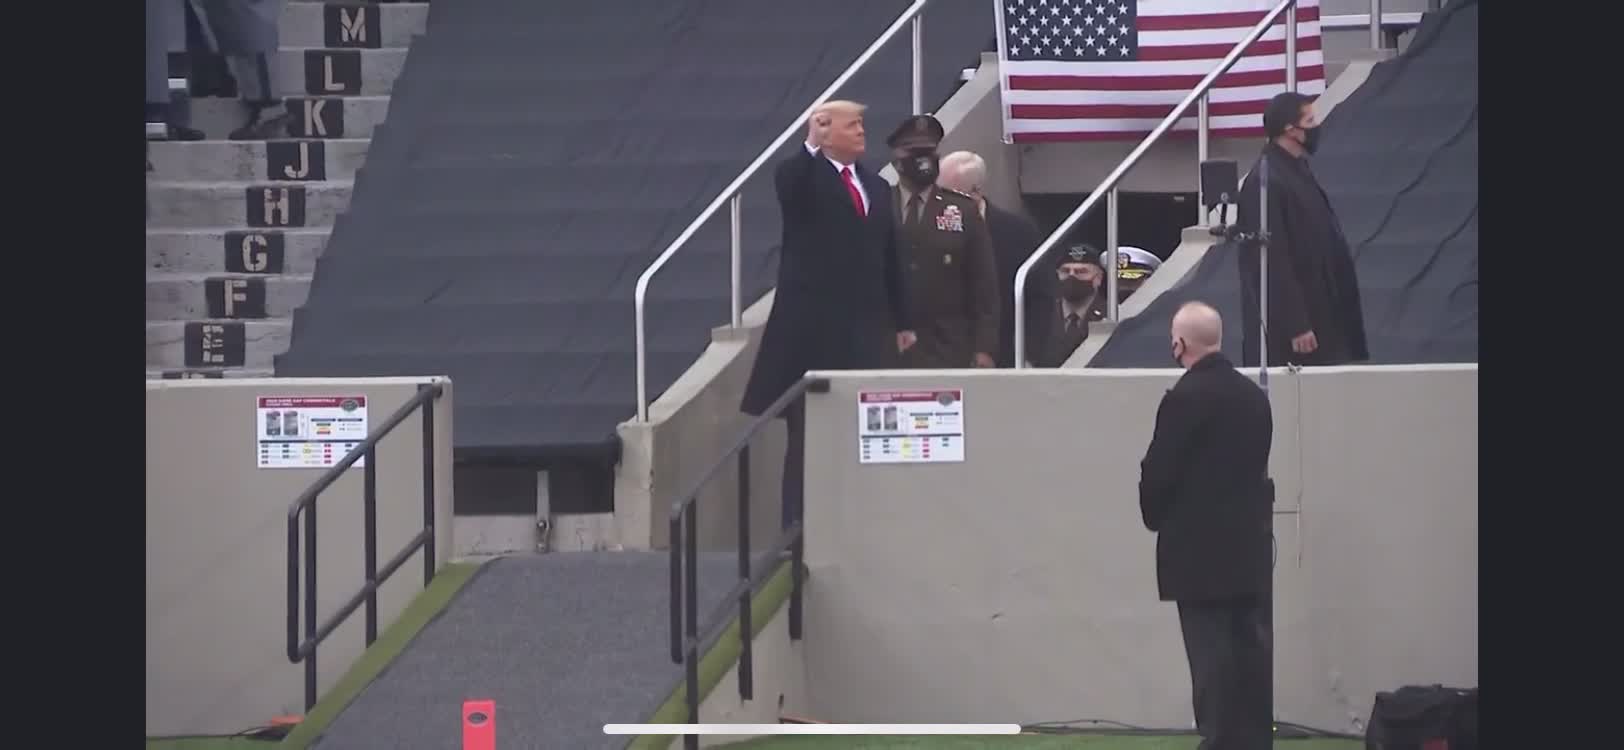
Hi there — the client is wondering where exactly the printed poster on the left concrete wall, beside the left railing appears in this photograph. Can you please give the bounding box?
[253,396,367,469]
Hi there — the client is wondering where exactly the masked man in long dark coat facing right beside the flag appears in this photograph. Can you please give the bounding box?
[1236,91,1371,365]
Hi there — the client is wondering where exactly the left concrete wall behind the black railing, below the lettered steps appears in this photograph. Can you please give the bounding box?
[146,378,453,737]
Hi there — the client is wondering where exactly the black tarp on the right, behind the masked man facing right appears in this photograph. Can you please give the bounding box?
[1088,0,1478,367]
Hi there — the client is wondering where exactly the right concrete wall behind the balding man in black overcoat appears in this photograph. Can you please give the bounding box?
[802,365,1478,732]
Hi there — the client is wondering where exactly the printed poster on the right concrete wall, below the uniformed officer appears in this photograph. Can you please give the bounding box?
[857,388,965,464]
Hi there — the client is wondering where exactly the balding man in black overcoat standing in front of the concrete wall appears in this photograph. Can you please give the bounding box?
[1138,302,1273,750]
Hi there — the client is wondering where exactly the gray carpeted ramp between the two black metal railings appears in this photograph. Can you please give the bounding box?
[313,552,737,750]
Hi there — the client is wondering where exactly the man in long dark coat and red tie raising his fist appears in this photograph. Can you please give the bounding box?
[741,101,916,526]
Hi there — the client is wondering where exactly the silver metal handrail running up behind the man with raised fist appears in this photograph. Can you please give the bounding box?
[635,0,931,422]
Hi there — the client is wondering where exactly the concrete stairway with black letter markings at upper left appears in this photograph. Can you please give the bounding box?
[146,0,429,378]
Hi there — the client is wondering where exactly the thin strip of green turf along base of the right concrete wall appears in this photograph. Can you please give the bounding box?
[719,734,1364,750]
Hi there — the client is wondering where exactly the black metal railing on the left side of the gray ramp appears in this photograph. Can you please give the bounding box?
[287,383,445,711]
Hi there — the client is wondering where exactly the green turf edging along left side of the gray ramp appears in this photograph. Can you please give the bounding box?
[146,563,481,750]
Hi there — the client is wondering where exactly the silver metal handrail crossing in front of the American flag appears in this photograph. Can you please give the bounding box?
[1015,0,1305,369]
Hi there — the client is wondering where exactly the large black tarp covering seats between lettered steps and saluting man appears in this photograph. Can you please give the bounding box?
[276,0,994,461]
